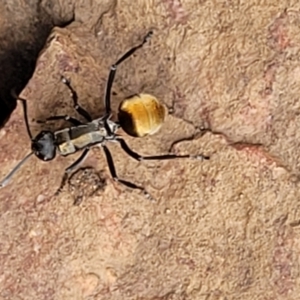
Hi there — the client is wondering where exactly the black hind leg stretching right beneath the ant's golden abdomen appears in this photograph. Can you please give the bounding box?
[116,138,209,161]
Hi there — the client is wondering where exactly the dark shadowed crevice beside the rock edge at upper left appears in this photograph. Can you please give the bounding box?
[0,4,73,128]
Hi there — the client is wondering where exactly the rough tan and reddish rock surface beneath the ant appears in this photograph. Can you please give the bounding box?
[0,0,300,300]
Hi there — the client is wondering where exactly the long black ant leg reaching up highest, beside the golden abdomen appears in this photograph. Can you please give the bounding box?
[105,31,153,118]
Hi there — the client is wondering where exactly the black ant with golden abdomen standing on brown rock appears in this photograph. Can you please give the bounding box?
[0,31,209,199]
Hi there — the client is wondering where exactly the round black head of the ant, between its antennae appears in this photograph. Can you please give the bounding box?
[31,131,56,161]
